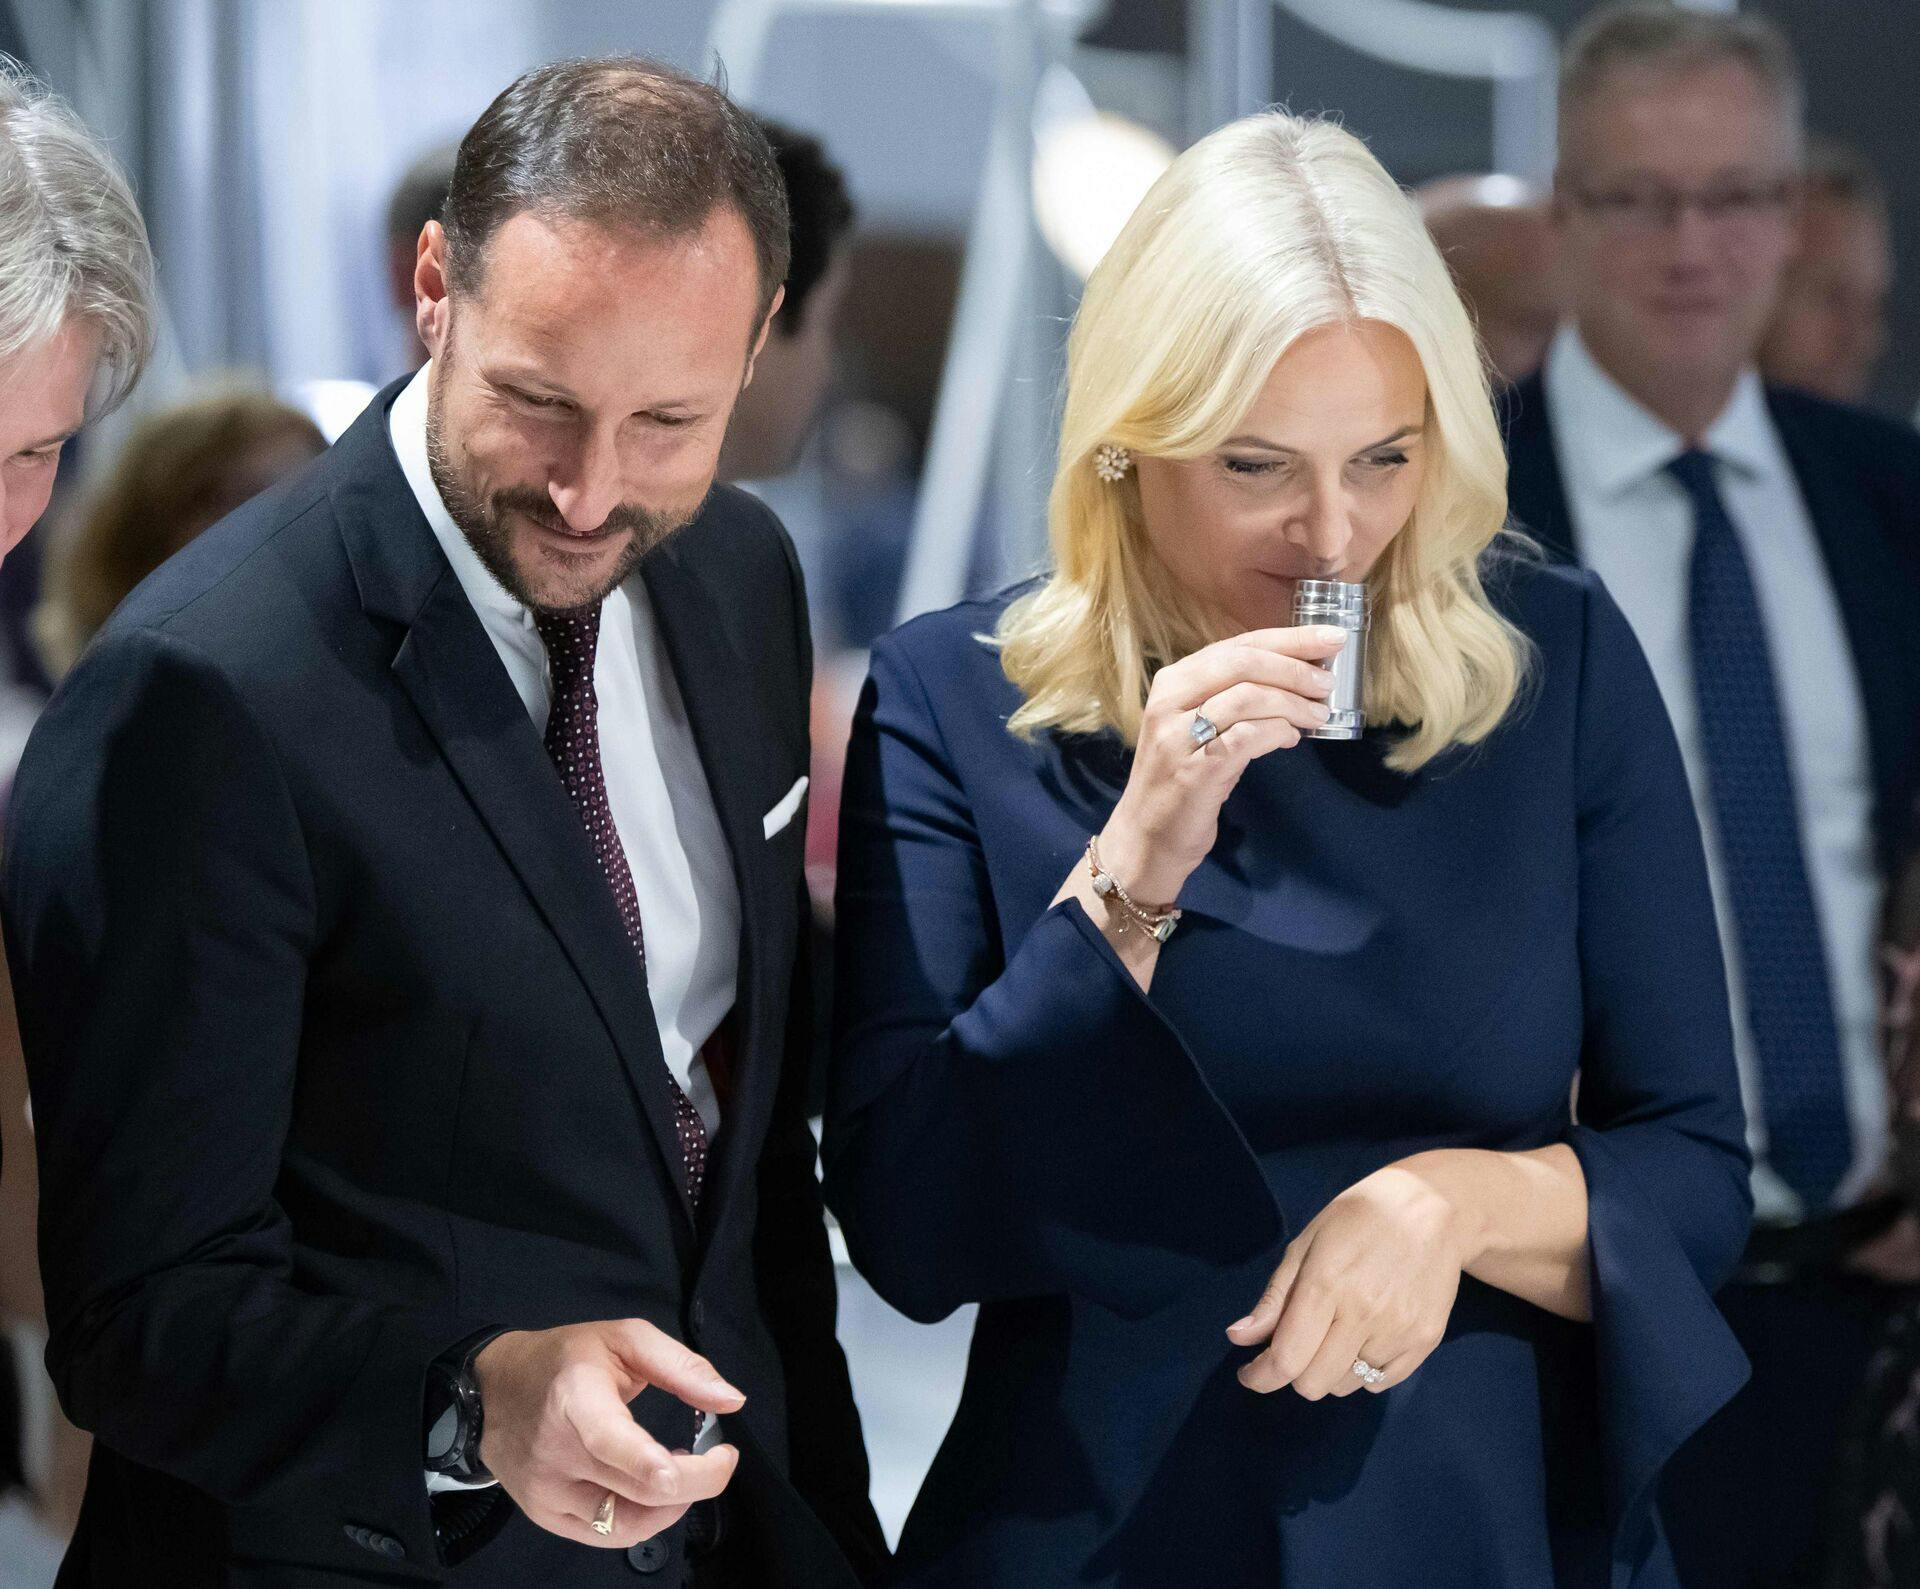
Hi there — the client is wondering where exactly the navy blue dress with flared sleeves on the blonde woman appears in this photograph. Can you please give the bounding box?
[826,560,1749,1589]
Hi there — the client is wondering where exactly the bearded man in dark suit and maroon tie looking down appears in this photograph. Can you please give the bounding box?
[4,59,883,1589]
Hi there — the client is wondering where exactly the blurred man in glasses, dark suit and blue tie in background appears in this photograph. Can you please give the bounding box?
[1503,6,1920,1589]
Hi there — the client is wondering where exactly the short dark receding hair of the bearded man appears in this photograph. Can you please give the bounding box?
[442,56,787,311]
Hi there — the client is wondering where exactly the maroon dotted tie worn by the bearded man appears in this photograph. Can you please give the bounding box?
[534,605,707,1209]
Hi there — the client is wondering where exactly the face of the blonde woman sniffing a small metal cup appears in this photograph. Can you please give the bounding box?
[1137,320,1427,629]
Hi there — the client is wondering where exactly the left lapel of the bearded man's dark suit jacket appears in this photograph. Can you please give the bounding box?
[332,386,693,1222]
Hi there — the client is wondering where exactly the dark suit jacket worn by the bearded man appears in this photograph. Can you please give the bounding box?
[4,388,881,1589]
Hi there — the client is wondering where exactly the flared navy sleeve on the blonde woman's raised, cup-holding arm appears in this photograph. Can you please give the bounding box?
[824,626,1283,1320]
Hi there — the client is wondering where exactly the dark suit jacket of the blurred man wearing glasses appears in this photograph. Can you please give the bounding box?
[1501,374,1920,871]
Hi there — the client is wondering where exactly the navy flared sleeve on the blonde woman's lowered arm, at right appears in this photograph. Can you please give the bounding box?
[1569,574,1753,1560]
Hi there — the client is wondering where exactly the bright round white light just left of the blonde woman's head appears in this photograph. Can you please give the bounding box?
[1033,65,1175,280]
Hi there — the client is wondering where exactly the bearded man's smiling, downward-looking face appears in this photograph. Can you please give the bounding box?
[415,207,778,610]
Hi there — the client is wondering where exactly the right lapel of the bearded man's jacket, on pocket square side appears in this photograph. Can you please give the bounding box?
[641,532,797,1232]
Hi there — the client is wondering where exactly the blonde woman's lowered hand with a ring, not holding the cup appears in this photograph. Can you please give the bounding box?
[1227,1165,1471,1401]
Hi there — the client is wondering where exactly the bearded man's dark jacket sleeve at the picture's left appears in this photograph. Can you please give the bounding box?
[0,628,474,1568]
